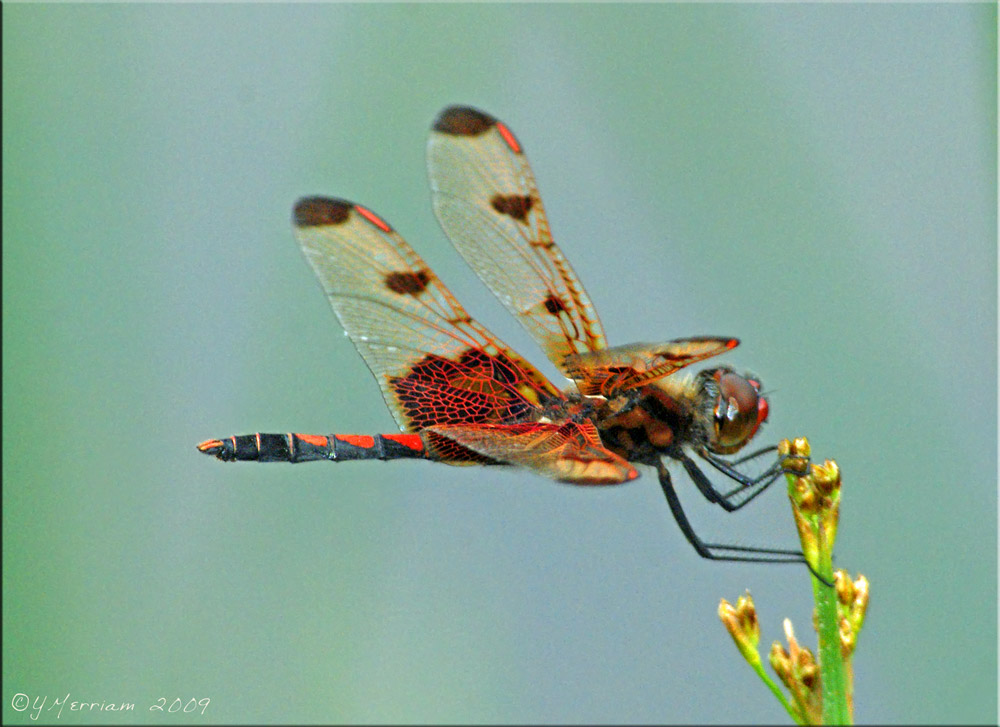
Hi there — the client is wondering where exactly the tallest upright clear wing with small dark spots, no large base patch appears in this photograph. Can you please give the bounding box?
[427,106,607,370]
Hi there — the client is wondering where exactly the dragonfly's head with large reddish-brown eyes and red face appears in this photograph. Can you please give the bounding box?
[700,366,768,454]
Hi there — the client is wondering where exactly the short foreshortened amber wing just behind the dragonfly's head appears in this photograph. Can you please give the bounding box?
[566,337,740,398]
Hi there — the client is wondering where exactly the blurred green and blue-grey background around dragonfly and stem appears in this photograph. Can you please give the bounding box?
[3,3,997,724]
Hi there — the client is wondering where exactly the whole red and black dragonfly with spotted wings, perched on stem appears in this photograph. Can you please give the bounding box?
[198,106,804,563]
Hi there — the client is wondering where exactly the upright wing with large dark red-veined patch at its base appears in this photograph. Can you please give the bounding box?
[295,197,560,431]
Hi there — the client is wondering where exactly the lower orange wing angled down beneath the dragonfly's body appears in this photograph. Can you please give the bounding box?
[424,420,639,485]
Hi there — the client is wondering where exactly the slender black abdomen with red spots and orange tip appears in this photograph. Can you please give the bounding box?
[198,432,427,464]
